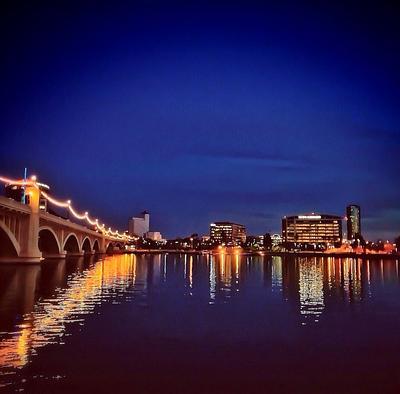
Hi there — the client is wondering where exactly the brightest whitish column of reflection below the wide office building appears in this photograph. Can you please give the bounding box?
[299,258,324,321]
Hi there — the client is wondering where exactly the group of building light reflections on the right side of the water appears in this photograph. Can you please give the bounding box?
[263,256,400,320]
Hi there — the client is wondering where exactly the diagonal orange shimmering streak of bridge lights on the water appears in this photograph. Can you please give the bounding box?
[0,255,138,368]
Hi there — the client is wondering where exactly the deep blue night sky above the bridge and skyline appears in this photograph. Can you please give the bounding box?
[0,1,400,238]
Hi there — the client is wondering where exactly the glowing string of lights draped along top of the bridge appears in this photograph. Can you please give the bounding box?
[0,175,134,241]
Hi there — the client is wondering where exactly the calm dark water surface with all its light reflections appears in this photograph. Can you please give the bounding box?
[0,254,400,393]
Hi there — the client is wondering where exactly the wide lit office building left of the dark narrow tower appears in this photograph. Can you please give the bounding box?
[282,213,342,245]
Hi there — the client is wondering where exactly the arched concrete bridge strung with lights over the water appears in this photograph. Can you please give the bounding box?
[0,177,133,263]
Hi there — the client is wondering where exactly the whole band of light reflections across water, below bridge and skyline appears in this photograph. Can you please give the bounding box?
[0,254,399,385]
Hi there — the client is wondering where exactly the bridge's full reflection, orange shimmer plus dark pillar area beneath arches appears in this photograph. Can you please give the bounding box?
[0,255,136,374]
